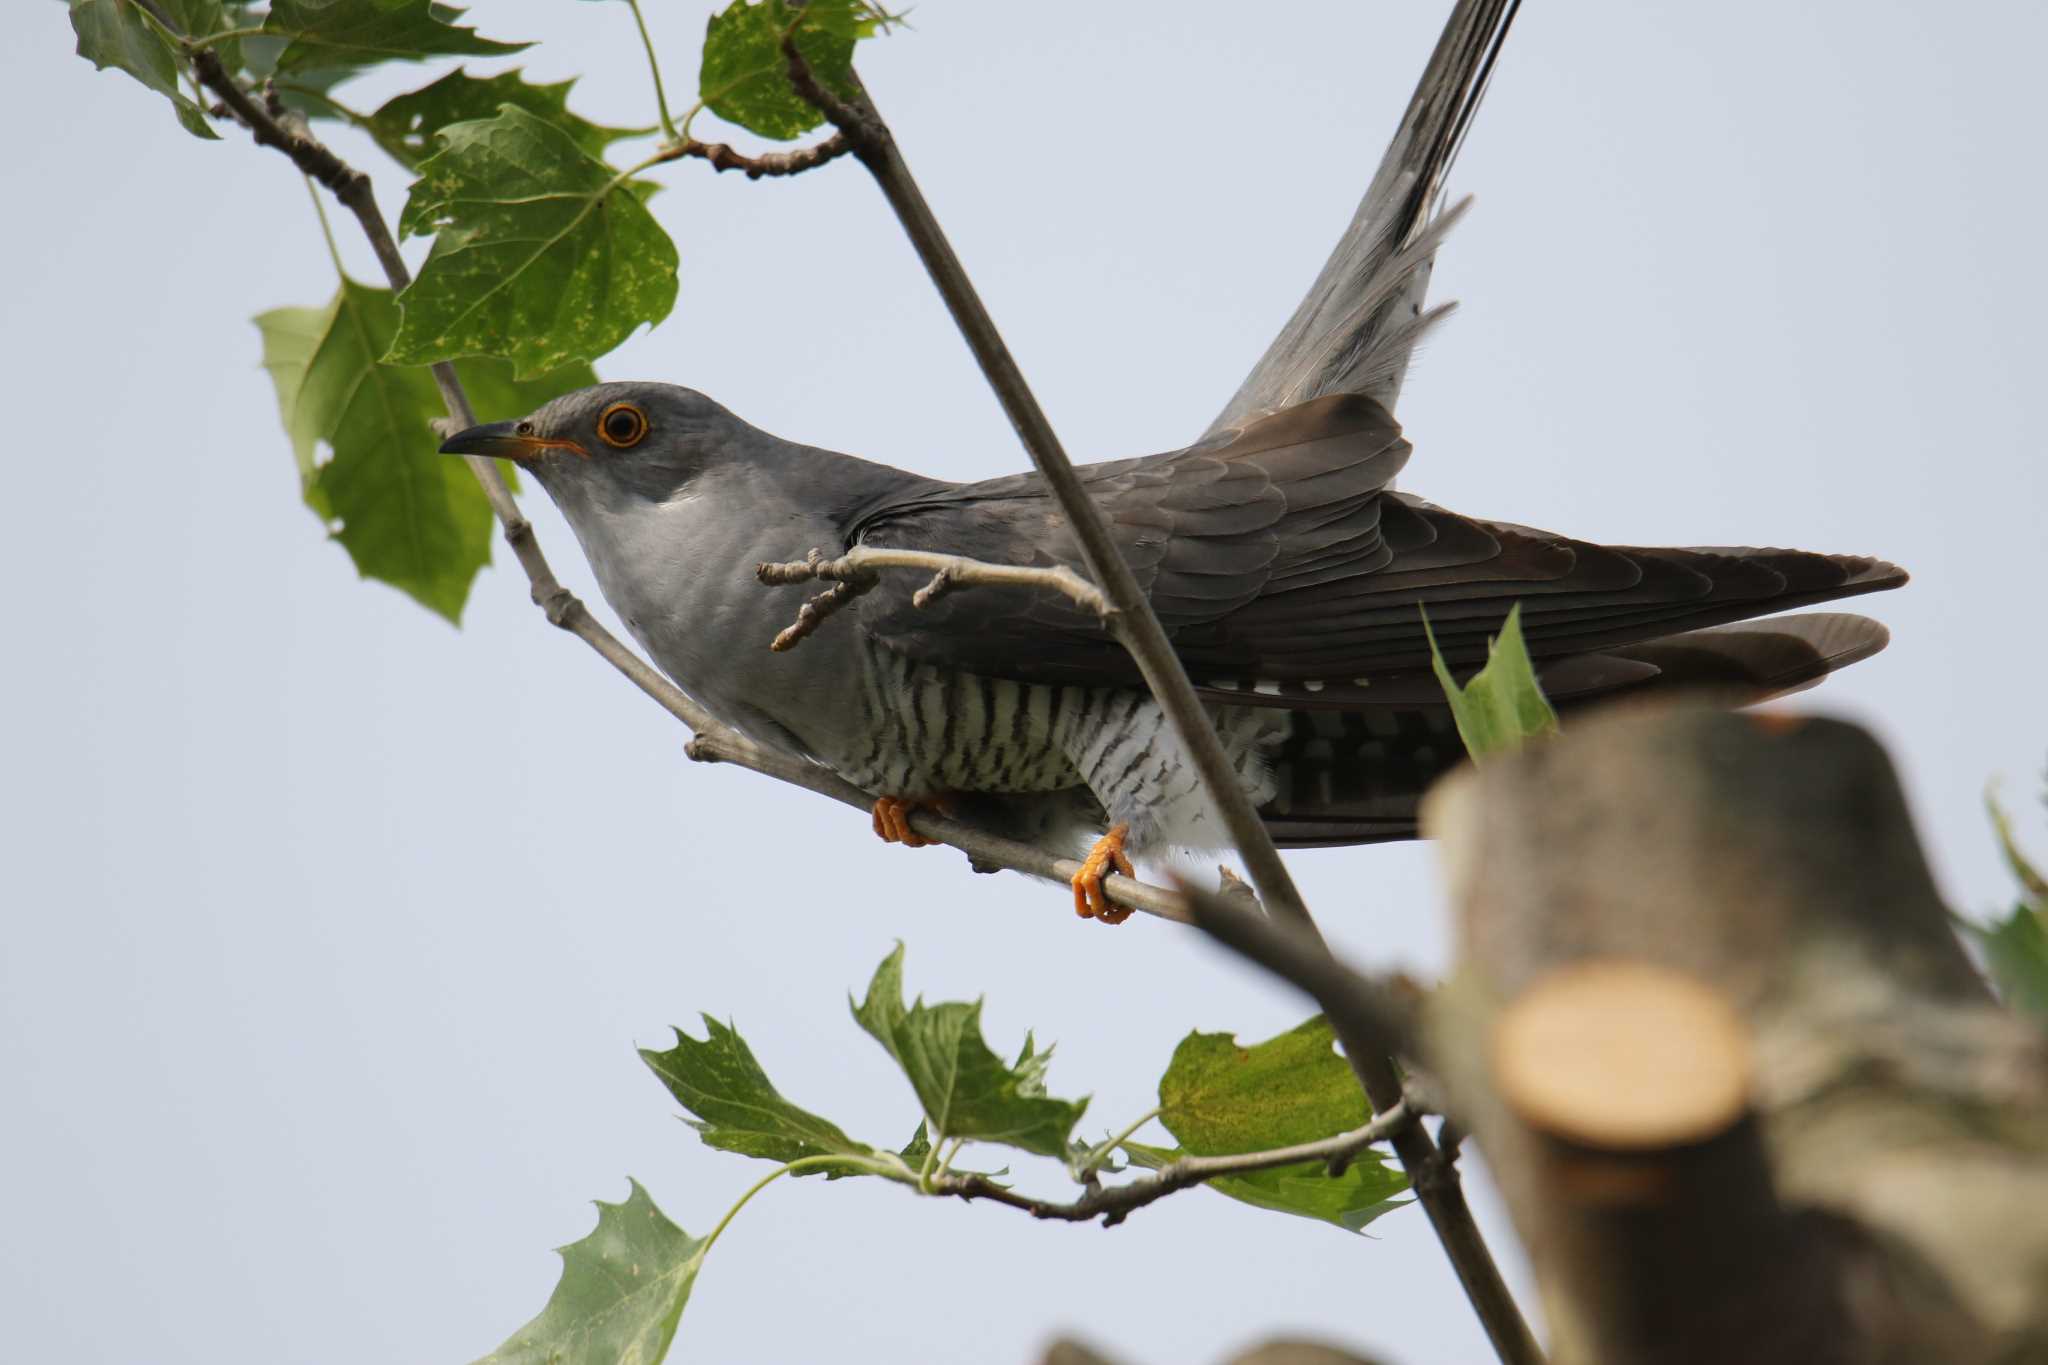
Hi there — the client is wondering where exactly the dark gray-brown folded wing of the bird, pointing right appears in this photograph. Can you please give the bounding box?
[848,395,1905,706]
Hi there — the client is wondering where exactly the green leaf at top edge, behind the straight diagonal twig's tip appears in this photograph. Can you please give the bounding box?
[696,0,877,141]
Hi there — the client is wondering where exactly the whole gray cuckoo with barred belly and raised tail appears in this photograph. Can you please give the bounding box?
[442,0,1907,923]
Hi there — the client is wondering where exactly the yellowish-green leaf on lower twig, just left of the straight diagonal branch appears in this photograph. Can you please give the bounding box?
[1159,1015,1372,1156]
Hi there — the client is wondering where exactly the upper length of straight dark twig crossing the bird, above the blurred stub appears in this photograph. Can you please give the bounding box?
[782,39,1315,929]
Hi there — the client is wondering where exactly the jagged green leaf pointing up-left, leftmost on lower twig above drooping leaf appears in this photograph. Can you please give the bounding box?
[641,1015,874,1162]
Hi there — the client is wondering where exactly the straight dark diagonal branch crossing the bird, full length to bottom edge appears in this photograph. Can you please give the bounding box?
[782,37,1542,1365]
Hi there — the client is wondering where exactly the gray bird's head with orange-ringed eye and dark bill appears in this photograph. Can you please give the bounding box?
[440,383,752,501]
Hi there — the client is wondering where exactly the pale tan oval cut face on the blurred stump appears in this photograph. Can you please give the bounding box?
[1491,960,1751,1152]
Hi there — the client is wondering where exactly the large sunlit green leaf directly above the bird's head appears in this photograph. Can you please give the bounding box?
[385,108,676,379]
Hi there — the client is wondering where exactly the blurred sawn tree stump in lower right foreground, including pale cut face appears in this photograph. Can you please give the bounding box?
[1423,708,2048,1365]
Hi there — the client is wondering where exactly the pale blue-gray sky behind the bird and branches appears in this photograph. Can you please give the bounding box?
[0,0,2048,1365]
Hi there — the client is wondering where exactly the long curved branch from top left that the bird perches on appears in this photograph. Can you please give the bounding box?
[137,0,1188,923]
